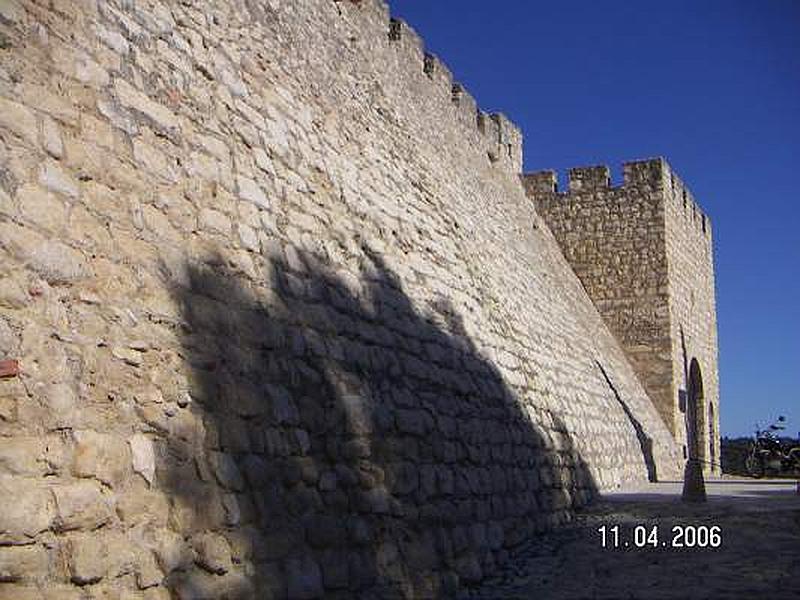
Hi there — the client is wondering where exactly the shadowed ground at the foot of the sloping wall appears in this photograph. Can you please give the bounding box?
[461,479,800,600]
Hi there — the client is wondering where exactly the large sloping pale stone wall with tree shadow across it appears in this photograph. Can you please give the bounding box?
[0,0,680,599]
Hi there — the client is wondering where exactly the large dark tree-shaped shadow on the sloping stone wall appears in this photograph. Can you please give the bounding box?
[158,248,595,598]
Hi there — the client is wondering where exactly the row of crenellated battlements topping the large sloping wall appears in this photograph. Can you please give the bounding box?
[334,0,522,174]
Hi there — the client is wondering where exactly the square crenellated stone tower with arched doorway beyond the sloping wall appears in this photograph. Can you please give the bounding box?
[523,158,719,471]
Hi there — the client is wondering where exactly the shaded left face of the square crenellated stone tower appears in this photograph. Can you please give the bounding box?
[523,161,675,434]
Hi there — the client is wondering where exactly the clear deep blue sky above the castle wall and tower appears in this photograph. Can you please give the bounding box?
[390,0,800,436]
